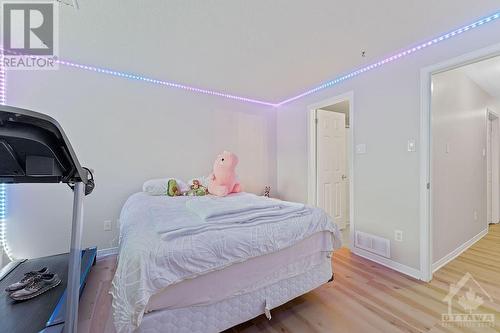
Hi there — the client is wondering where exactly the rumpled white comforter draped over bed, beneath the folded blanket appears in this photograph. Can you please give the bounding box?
[111,193,341,332]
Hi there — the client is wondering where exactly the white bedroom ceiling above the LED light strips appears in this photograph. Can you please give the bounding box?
[60,0,499,101]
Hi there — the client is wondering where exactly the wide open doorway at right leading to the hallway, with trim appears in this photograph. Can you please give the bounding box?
[421,48,500,280]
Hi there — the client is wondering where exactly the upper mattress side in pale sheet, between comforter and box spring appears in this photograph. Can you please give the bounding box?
[146,232,333,312]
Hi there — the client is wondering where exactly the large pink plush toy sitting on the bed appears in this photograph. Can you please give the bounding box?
[208,151,241,197]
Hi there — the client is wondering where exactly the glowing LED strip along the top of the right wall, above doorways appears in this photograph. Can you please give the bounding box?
[277,12,500,107]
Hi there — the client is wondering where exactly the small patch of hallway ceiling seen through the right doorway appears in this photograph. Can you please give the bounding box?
[462,56,500,101]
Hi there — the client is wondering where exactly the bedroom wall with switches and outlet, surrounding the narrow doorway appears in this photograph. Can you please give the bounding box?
[277,22,500,269]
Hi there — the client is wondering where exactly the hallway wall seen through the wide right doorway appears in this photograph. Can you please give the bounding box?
[431,69,492,263]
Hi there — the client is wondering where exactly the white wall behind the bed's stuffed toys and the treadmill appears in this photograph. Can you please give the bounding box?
[7,67,276,257]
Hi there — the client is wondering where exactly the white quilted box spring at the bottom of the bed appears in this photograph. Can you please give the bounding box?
[135,256,332,333]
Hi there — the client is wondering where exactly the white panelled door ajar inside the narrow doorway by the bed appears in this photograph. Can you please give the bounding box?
[316,110,346,229]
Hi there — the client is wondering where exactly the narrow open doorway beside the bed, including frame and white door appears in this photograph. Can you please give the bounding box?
[309,93,354,247]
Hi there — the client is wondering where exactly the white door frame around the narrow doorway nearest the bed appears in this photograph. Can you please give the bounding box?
[307,91,355,247]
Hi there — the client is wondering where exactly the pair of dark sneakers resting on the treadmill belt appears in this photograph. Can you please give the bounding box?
[5,267,61,301]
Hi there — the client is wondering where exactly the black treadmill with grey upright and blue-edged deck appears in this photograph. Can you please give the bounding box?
[0,105,97,333]
